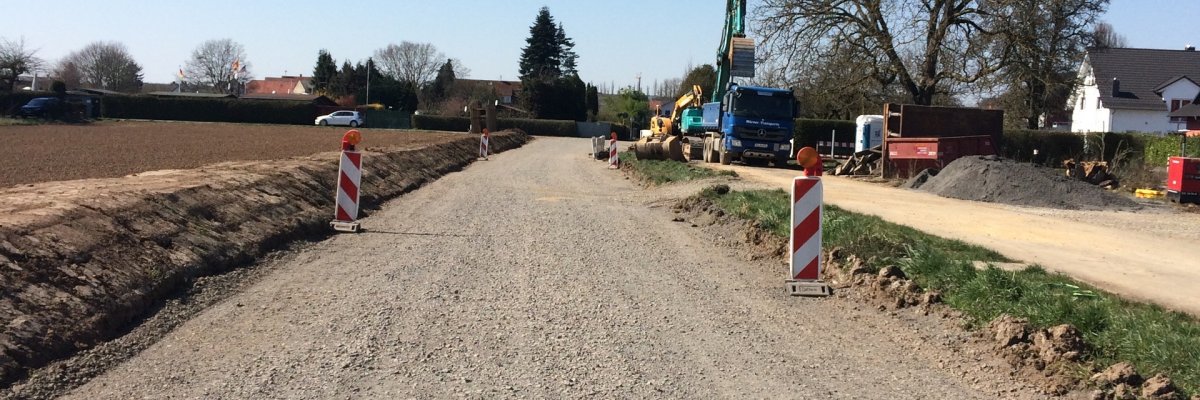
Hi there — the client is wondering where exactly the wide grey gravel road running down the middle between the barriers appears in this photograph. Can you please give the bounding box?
[60,138,1038,399]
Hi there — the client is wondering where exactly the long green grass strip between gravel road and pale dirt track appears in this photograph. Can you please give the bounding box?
[700,189,1200,393]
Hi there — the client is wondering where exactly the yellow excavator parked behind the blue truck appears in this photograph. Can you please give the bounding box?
[634,85,703,162]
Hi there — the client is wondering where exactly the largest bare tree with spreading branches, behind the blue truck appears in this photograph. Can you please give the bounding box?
[755,0,1006,105]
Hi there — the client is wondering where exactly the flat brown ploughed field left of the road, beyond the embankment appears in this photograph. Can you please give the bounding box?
[0,121,461,187]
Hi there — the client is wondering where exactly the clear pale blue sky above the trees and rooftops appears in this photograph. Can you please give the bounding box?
[0,0,1200,88]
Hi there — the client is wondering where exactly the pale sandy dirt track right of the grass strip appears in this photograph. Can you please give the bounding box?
[708,165,1200,316]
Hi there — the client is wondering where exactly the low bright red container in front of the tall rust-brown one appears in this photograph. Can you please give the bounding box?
[886,136,996,177]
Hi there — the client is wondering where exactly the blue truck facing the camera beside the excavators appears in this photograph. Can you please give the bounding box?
[703,84,796,167]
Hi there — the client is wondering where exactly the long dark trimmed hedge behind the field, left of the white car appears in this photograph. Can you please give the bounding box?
[101,96,318,125]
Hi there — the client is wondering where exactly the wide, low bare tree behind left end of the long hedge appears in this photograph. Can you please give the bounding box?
[55,42,142,92]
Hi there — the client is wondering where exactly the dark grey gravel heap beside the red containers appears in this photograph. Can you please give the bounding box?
[919,156,1138,209]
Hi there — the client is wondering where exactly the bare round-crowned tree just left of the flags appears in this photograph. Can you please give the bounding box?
[185,38,252,92]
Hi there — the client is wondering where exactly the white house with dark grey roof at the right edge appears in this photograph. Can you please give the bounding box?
[1067,46,1200,133]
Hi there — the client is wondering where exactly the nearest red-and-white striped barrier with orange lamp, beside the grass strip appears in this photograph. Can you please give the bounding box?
[786,177,829,295]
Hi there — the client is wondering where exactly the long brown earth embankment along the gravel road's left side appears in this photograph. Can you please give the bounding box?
[0,132,529,384]
